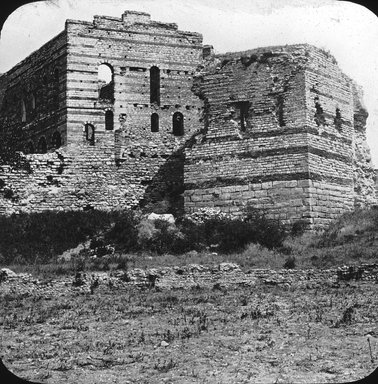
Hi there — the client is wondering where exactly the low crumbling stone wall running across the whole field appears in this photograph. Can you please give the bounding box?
[0,263,378,296]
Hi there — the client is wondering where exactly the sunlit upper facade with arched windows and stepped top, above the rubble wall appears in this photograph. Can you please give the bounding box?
[66,12,202,146]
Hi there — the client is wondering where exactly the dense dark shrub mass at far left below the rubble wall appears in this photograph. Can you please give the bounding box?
[0,210,128,263]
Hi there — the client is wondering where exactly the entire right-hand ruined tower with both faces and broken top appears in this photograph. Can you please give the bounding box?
[185,44,375,228]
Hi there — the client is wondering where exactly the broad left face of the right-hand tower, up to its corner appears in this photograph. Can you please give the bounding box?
[185,46,311,223]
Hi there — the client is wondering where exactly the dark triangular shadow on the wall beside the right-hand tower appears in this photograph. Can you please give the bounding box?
[139,132,201,217]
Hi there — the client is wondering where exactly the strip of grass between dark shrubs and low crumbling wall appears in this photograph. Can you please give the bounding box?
[5,232,378,278]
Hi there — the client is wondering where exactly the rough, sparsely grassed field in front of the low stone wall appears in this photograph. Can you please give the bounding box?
[0,276,378,384]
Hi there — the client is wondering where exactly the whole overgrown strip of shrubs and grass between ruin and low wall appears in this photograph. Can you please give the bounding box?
[0,209,378,275]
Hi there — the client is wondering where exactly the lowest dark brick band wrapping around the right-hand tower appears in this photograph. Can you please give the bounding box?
[184,172,353,190]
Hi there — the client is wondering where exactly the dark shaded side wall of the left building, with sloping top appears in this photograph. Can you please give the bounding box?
[0,31,67,151]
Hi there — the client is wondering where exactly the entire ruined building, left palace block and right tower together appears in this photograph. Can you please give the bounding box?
[0,11,375,227]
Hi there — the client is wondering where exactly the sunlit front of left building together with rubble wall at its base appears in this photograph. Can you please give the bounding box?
[0,12,202,213]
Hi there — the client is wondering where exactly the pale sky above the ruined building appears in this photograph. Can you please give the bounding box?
[0,0,378,164]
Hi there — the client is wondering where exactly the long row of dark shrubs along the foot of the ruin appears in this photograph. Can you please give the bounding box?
[0,209,286,269]
